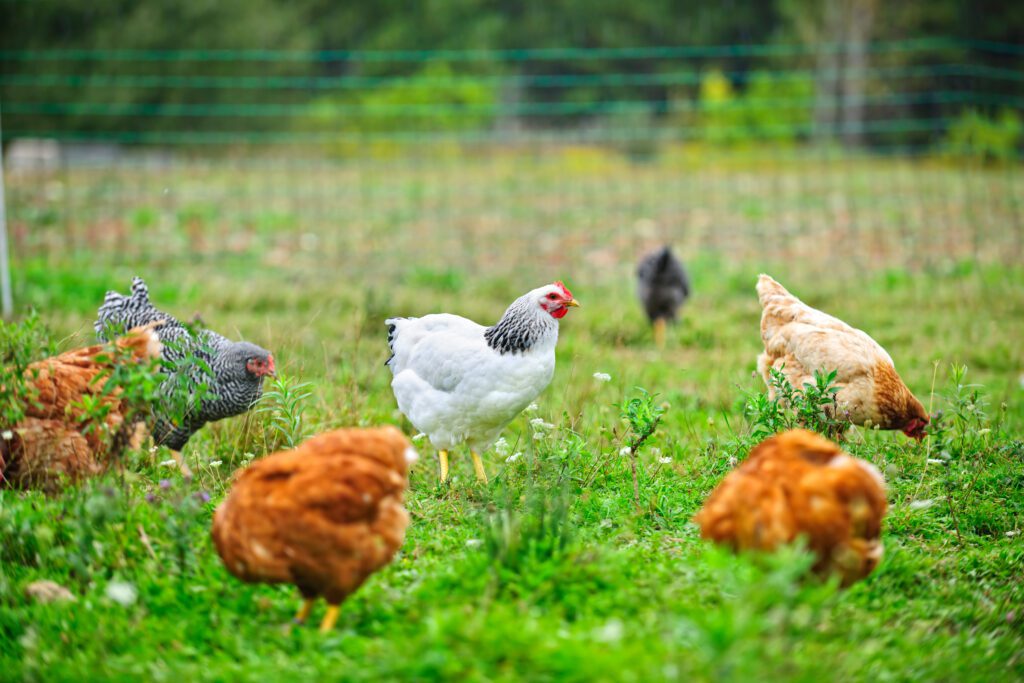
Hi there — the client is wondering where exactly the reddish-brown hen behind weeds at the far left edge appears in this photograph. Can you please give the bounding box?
[0,323,161,490]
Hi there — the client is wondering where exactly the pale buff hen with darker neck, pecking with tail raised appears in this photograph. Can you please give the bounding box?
[758,274,929,439]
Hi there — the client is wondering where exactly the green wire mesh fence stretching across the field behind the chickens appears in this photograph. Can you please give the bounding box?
[0,39,1024,286]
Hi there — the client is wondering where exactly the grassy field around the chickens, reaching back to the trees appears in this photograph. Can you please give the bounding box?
[0,150,1024,681]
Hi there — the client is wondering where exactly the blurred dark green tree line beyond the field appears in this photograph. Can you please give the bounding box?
[0,0,1024,153]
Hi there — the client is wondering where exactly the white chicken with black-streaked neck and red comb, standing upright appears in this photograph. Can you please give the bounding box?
[386,282,580,482]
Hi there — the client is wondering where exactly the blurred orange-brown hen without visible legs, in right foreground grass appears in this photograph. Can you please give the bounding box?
[694,429,887,586]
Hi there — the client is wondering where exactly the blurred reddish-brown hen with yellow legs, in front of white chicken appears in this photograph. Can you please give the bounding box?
[213,427,416,632]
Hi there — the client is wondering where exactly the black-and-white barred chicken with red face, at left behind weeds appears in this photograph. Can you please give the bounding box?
[93,278,274,451]
